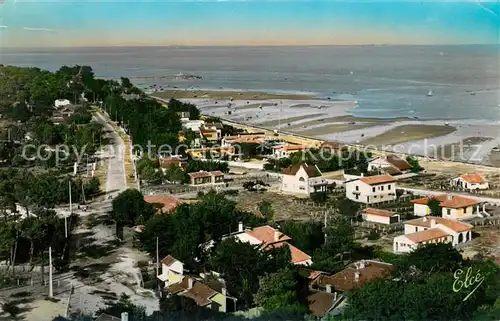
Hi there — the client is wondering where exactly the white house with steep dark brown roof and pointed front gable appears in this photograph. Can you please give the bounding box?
[281,163,328,195]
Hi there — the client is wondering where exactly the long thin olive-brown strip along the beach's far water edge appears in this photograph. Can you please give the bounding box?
[152,90,314,100]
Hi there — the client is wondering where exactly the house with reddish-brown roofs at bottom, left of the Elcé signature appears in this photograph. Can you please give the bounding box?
[308,260,393,317]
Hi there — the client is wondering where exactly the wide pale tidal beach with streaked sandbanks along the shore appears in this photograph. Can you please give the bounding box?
[155,91,500,166]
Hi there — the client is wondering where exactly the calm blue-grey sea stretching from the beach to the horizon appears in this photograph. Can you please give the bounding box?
[0,46,500,122]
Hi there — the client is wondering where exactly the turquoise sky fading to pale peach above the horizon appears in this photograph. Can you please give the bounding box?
[0,0,500,47]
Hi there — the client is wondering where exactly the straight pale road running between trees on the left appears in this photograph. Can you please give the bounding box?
[96,113,127,195]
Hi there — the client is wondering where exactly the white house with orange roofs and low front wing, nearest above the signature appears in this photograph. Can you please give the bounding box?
[393,216,473,253]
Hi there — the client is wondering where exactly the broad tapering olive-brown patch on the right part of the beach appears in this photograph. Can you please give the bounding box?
[361,125,456,146]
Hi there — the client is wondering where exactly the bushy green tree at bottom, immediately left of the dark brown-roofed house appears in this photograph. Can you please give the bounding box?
[255,269,306,314]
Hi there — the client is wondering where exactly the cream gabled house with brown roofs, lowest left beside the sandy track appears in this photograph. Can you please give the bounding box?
[158,255,237,312]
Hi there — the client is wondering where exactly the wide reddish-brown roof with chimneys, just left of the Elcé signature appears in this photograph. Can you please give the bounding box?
[314,260,393,292]
